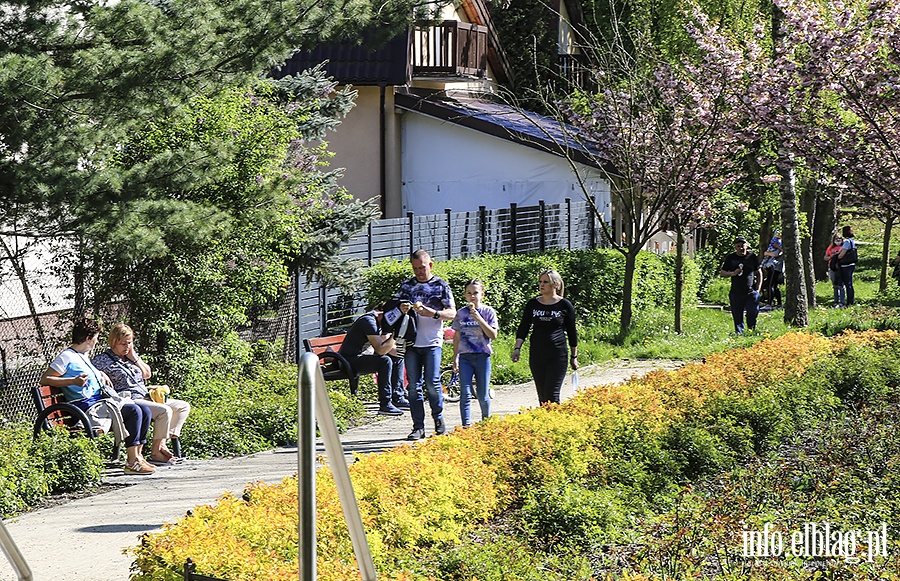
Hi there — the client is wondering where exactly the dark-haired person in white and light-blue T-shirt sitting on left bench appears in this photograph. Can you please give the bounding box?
[41,318,156,475]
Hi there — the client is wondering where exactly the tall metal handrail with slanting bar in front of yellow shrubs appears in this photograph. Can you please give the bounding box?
[297,353,377,581]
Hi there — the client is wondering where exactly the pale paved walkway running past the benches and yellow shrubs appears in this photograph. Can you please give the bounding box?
[0,361,678,581]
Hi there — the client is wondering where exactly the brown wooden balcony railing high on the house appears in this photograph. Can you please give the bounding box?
[410,20,488,78]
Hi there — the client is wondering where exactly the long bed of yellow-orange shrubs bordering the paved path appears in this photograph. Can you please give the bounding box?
[133,332,864,581]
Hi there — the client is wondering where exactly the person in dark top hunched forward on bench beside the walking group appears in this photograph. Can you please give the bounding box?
[339,304,403,416]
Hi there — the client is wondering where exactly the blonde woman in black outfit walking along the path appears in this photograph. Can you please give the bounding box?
[512,269,578,405]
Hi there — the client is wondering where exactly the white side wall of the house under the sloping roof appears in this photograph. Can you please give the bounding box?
[401,112,610,219]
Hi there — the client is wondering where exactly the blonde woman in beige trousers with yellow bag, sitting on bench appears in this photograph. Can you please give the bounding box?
[91,323,191,464]
